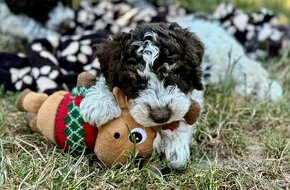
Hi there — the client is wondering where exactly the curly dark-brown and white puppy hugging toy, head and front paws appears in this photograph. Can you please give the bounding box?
[80,23,204,168]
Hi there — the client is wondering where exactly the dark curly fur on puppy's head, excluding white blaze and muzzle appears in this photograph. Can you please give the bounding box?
[95,23,204,98]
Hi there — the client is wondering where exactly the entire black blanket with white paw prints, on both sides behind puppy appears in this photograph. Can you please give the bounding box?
[0,1,290,93]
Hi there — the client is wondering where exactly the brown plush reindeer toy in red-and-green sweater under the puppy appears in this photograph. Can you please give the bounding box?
[17,73,156,167]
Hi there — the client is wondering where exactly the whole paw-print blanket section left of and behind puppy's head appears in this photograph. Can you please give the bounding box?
[0,1,184,93]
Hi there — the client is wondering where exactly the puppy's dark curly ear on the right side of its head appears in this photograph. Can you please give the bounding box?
[169,23,204,90]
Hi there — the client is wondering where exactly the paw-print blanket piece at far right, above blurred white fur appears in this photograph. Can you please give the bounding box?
[212,4,290,58]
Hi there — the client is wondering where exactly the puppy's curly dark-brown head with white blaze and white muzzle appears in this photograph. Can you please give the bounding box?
[96,23,203,126]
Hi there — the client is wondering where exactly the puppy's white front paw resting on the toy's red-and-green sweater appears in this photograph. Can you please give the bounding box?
[80,76,121,127]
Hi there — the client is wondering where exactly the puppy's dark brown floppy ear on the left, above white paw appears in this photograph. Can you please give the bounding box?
[94,33,131,90]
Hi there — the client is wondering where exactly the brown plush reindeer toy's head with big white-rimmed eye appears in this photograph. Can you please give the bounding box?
[95,88,156,165]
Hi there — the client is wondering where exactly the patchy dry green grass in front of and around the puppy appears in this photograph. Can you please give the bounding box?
[0,0,290,190]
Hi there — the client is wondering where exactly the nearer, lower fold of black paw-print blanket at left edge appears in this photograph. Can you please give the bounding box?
[0,33,107,93]
